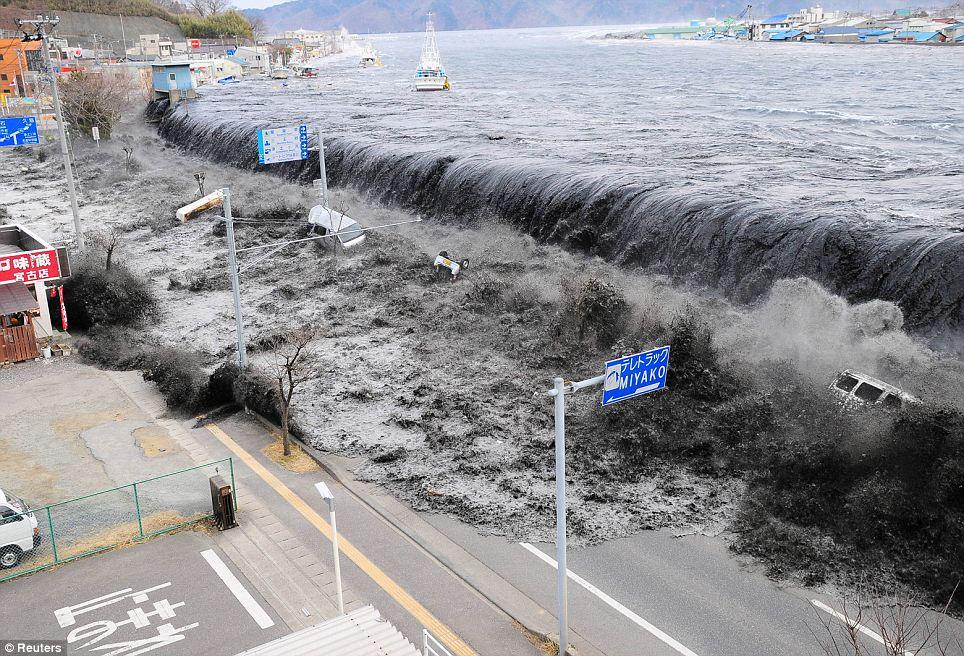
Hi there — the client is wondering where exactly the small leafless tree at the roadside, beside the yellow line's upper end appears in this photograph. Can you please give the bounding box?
[266,326,318,456]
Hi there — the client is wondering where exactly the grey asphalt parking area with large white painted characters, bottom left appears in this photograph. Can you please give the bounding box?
[0,531,289,656]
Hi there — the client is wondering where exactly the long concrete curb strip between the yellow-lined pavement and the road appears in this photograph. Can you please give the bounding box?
[245,409,605,656]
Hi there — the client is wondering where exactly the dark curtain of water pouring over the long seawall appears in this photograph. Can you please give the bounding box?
[148,102,964,338]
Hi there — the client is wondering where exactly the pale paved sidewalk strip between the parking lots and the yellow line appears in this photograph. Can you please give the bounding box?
[108,371,364,631]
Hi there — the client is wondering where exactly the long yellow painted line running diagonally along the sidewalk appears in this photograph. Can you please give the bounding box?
[205,424,476,656]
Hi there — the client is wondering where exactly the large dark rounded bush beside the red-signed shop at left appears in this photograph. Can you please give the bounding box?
[64,258,157,329]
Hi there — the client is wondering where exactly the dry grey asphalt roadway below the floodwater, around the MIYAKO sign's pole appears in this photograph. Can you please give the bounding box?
[427,515,964,656]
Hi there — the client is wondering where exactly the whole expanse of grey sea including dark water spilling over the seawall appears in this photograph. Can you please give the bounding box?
[153,28,964,335]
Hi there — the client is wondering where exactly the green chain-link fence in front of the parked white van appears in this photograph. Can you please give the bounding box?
[0,458,234,582]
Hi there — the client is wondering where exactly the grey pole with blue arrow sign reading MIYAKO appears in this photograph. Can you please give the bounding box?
[548,346,669,656]
